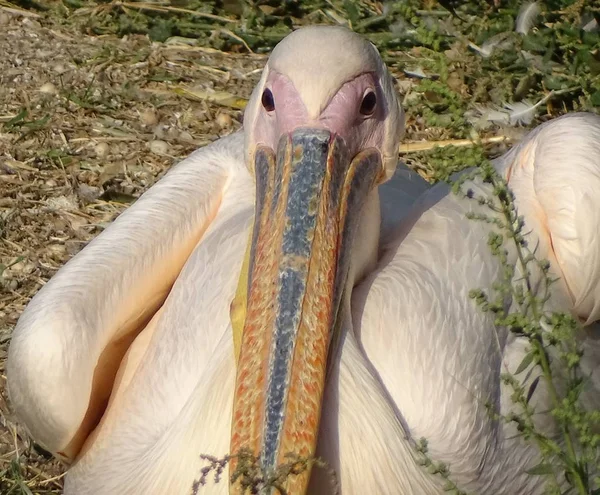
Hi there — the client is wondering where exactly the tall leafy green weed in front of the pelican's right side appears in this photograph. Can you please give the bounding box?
[453,161,600,495]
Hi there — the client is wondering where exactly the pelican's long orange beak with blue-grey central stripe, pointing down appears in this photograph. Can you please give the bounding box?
[230,128,383,495]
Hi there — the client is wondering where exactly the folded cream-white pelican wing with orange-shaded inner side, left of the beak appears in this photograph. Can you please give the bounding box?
[7,133,244,461]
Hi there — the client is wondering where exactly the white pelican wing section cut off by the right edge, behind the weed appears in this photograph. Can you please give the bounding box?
[496,113,600,324]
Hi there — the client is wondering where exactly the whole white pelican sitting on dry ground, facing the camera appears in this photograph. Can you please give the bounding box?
[7,27,600,495]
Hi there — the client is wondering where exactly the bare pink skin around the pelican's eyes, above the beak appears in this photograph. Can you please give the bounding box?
[254,72,388,160]
